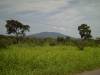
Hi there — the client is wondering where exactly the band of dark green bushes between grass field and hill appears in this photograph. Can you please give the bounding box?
[0,35,100,50]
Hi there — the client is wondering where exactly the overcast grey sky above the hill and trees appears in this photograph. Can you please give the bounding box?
[0,0,100,37]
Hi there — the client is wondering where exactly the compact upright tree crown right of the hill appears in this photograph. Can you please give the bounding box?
[78,24,92,39]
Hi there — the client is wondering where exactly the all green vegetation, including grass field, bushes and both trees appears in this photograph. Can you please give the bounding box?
[0,20,100,75]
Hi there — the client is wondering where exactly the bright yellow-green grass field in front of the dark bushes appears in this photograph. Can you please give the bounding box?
[0,45,100,75]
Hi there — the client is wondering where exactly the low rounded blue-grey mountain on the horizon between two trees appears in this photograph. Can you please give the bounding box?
[28,32,69,38]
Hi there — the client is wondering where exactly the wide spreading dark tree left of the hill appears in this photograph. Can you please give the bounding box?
[5,20,30,42]
